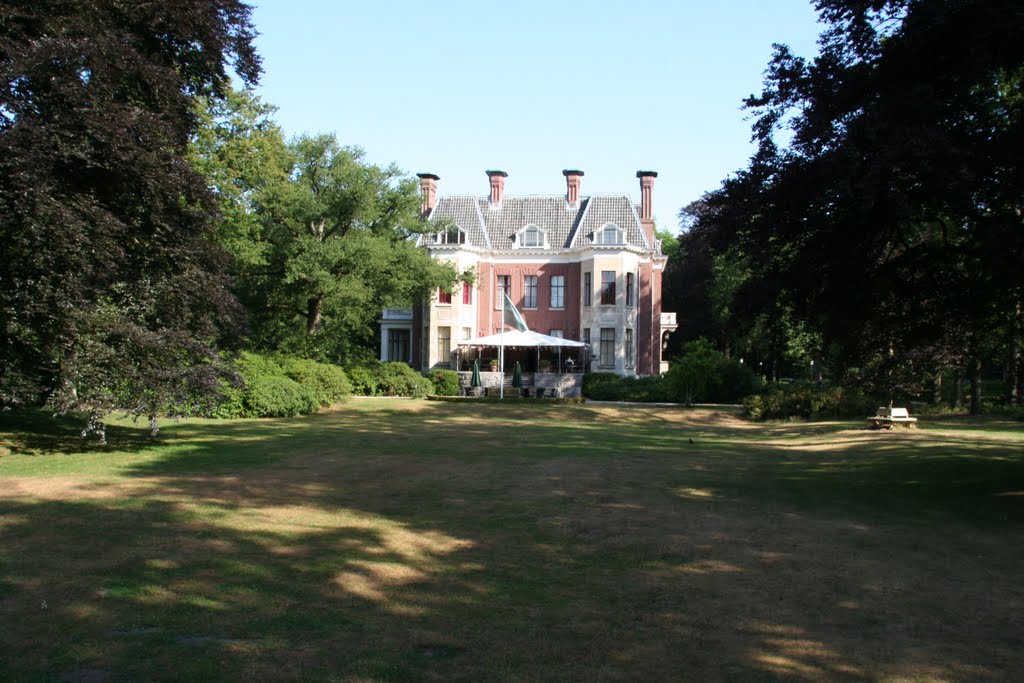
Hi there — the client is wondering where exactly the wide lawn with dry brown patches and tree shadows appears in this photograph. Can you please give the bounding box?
[0,399,1024,681]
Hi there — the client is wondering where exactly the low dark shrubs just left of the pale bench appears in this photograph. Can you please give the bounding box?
[743,383,879,420]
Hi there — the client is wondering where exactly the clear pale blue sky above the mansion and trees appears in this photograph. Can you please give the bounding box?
[247,0,821,231]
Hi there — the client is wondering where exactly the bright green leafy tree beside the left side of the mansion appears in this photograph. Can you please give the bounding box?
[193,92,457,362]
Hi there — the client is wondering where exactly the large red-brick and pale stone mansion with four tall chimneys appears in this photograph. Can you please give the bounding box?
[381,170,676,376]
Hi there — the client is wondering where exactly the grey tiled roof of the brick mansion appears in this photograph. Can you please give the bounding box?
[421,195,650,251]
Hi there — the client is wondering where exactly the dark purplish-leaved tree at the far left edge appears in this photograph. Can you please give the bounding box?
[0,0,259,428]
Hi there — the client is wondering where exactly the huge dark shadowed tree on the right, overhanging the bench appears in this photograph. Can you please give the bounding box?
[675,0,1024,409]
